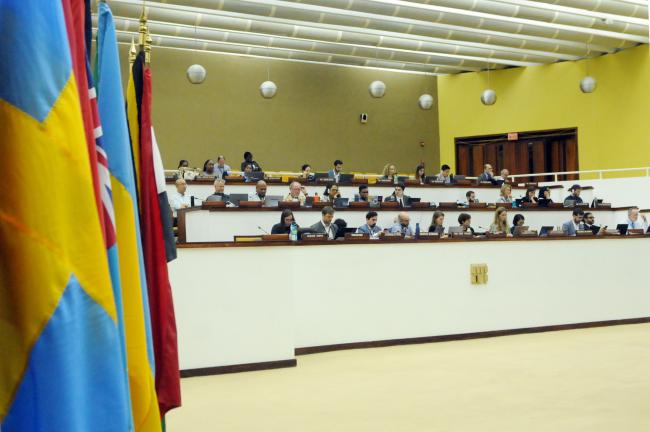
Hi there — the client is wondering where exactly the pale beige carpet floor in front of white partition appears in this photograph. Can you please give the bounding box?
[167,324,650,432]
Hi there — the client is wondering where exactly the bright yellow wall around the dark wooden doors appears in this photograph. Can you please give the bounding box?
[438,45,650,177]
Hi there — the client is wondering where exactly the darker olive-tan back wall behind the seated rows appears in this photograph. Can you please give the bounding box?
[120,46,439,173]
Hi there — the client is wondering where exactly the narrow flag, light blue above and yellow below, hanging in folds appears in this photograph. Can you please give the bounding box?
[95,2,161,432]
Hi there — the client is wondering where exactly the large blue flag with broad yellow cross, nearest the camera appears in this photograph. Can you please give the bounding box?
[0,0,130,432]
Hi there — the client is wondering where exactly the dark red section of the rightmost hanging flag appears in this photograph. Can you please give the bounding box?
[140,67,181,416]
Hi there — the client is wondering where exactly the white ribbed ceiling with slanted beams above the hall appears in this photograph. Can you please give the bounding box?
[93,0,649,74]
